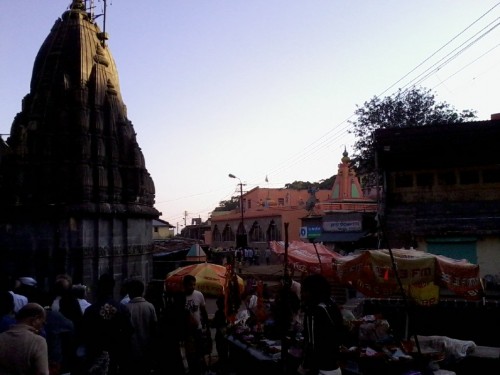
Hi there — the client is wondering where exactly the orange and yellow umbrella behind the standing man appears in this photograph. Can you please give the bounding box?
[165,262,244,296]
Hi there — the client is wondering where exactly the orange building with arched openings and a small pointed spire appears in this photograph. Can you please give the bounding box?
[211,151,377,251]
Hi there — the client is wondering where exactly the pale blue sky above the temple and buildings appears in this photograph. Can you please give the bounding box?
[0,0,500,227]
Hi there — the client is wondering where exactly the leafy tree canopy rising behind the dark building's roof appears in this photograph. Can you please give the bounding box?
[349,88,476,181]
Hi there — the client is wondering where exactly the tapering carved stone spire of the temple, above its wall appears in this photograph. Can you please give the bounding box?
[0,0,158,216]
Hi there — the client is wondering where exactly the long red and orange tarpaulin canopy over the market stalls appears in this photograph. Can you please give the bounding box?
[271,241,482,300]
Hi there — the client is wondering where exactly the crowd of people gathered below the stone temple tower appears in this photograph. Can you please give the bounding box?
[0,274,203,375]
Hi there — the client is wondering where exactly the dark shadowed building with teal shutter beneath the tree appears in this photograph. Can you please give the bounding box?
[374,116,500,278]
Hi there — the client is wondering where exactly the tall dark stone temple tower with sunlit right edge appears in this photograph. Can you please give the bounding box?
[0,0,160,285]
